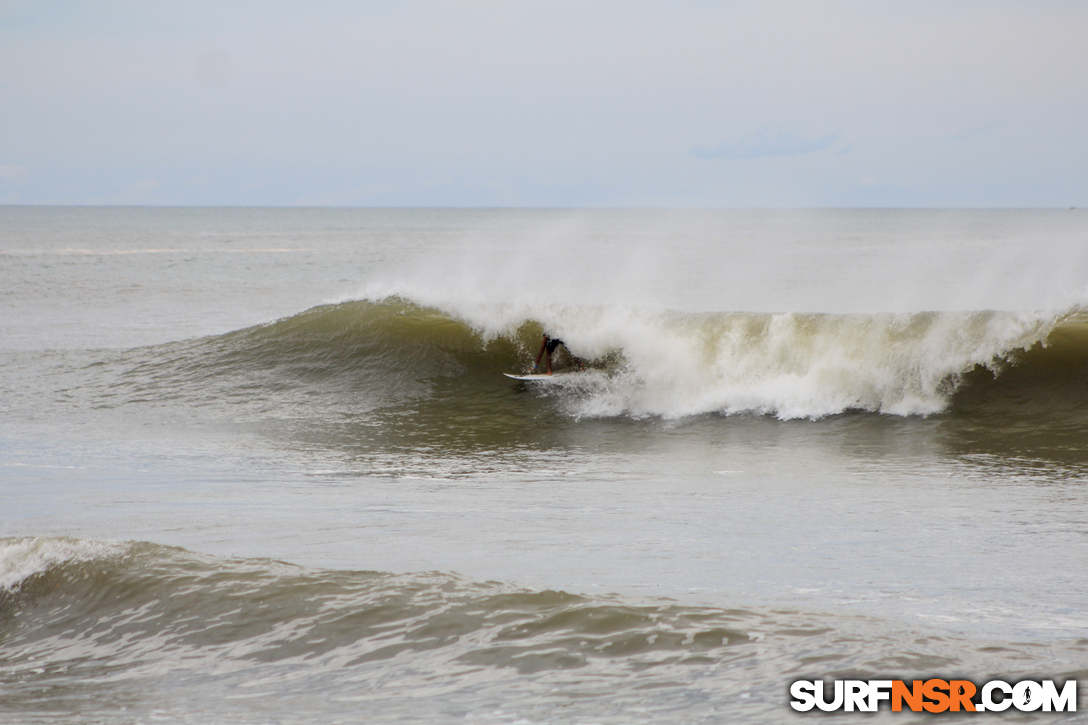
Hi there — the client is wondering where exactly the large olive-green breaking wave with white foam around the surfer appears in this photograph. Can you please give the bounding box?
[93,297,1088,419]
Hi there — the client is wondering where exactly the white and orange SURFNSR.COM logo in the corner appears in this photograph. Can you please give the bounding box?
[790,679,1077,713]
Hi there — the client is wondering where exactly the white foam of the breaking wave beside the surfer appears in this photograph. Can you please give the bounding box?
[385,295,1060,419]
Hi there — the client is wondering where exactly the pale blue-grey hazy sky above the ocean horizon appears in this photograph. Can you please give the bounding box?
[0,0,1088,208]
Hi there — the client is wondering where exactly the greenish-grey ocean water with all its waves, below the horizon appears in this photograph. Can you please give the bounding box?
[0,207,1088,723]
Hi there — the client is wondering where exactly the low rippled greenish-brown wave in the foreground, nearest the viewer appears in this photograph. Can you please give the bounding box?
[0,538,1079,722]
